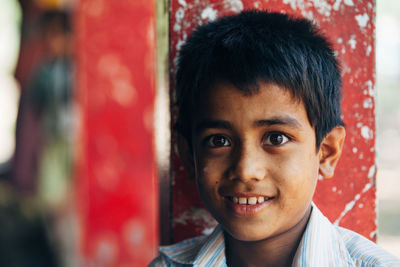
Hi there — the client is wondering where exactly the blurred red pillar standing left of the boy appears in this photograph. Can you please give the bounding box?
[76,0,158,266]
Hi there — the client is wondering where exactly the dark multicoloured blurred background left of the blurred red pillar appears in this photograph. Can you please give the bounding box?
[0,0,77,266]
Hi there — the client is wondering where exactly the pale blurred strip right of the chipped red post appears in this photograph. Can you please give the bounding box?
[376,0,400,257]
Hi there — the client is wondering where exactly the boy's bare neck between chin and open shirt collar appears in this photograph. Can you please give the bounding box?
[225,206,311,267]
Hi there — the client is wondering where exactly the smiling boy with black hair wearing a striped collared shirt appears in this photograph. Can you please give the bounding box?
[151,11,400,266]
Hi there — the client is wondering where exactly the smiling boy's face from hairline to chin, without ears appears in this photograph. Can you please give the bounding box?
[192,83,321,241]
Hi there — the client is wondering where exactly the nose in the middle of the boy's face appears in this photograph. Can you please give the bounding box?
[231,145,267,182]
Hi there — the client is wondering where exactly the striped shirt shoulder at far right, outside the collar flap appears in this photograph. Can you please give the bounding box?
[337,227,400,267]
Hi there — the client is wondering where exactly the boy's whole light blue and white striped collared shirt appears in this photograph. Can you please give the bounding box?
[149,204,400,267]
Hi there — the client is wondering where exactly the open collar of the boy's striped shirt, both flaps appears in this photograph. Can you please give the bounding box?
[160,203,354,267]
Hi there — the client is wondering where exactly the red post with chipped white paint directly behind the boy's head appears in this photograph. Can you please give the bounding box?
[170,0,376,241]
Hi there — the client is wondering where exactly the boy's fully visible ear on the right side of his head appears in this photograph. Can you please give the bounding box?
[318,126,346,178]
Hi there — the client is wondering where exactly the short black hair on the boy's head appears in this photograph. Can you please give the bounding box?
[175,10,343,148]
